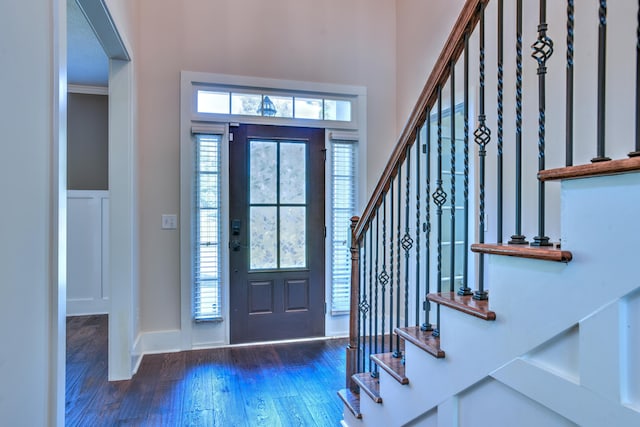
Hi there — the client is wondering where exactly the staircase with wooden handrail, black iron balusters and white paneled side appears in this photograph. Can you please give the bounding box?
[338,0,640,427]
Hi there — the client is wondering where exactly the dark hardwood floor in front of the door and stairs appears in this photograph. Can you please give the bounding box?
[66,316,347,427]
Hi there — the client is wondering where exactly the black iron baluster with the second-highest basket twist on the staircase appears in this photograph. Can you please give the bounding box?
[473,2,491,300]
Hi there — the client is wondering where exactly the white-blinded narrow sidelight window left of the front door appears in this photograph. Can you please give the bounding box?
[192,134,222,321]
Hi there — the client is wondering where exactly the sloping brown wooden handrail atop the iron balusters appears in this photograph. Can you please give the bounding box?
[355,0,489,241]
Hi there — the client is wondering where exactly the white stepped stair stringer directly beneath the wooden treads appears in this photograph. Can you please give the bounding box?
[342,173,640,426]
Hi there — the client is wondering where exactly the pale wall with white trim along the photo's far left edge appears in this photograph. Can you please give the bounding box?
[0,0,66,426]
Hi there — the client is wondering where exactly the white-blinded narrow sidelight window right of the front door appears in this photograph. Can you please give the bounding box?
[331,140,358,314]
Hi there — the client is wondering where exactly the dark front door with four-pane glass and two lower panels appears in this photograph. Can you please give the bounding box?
[229,125,325,343]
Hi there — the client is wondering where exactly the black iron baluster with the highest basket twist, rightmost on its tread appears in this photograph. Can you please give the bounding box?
[531,0,553,246]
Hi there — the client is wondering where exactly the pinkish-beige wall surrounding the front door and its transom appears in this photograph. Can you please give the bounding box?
[136,0,395,342]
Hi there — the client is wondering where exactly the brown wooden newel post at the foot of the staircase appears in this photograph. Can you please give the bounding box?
[346,216,360,391]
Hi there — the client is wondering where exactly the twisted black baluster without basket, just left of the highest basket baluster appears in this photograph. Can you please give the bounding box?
[509,0,529,245]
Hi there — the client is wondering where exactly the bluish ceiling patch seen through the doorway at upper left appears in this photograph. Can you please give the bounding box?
[67,0,109,87]
